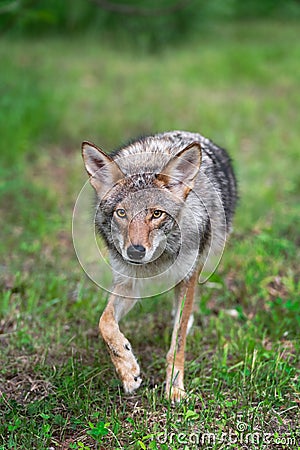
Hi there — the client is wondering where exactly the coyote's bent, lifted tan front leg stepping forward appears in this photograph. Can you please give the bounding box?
[99,293,142,393]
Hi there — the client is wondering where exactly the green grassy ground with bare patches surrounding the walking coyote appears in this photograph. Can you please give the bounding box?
[0,23,300,450]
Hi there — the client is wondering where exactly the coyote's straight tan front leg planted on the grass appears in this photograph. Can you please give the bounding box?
[166,271,199,402]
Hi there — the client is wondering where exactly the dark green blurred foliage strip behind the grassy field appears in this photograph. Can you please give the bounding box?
[0,0,300,43]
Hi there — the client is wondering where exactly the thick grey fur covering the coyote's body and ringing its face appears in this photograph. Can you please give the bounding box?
[84,131,237,292]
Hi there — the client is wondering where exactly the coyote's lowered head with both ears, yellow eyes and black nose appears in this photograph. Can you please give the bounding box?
[82,142,201,265]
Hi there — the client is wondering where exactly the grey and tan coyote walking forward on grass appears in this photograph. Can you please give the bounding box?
[82,131,237,402]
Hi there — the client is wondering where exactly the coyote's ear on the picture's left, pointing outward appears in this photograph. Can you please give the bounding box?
[82,141,124,196]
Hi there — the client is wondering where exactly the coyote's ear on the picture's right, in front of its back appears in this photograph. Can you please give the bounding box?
[157,142,202,199]
